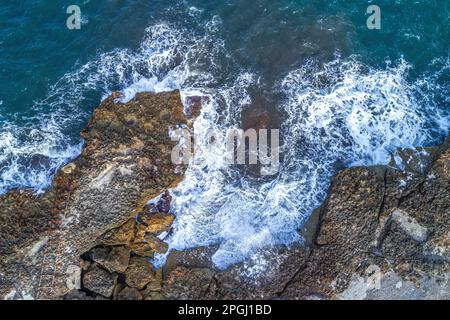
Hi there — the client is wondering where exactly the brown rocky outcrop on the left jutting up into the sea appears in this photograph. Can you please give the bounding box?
[0,91,188,299]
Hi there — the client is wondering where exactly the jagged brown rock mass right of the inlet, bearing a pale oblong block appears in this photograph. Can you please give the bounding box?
[280,140,450,299]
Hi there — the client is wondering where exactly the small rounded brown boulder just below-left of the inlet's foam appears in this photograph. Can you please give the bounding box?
[125,256,158,290]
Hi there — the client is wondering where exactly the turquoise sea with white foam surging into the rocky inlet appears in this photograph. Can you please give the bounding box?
[0,0,450,267]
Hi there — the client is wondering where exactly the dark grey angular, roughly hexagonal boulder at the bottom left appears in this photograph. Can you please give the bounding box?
[83,264,117,298]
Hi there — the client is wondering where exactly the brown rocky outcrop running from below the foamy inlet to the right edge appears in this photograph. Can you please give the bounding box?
[156,139,450,299]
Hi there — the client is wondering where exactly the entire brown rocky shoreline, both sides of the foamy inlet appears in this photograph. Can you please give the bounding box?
[0,91,450,300]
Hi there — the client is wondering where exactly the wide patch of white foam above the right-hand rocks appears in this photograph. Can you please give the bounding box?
[281,58,449,166]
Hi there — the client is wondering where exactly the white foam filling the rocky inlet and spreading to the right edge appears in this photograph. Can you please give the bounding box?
[102,21,448,270]
